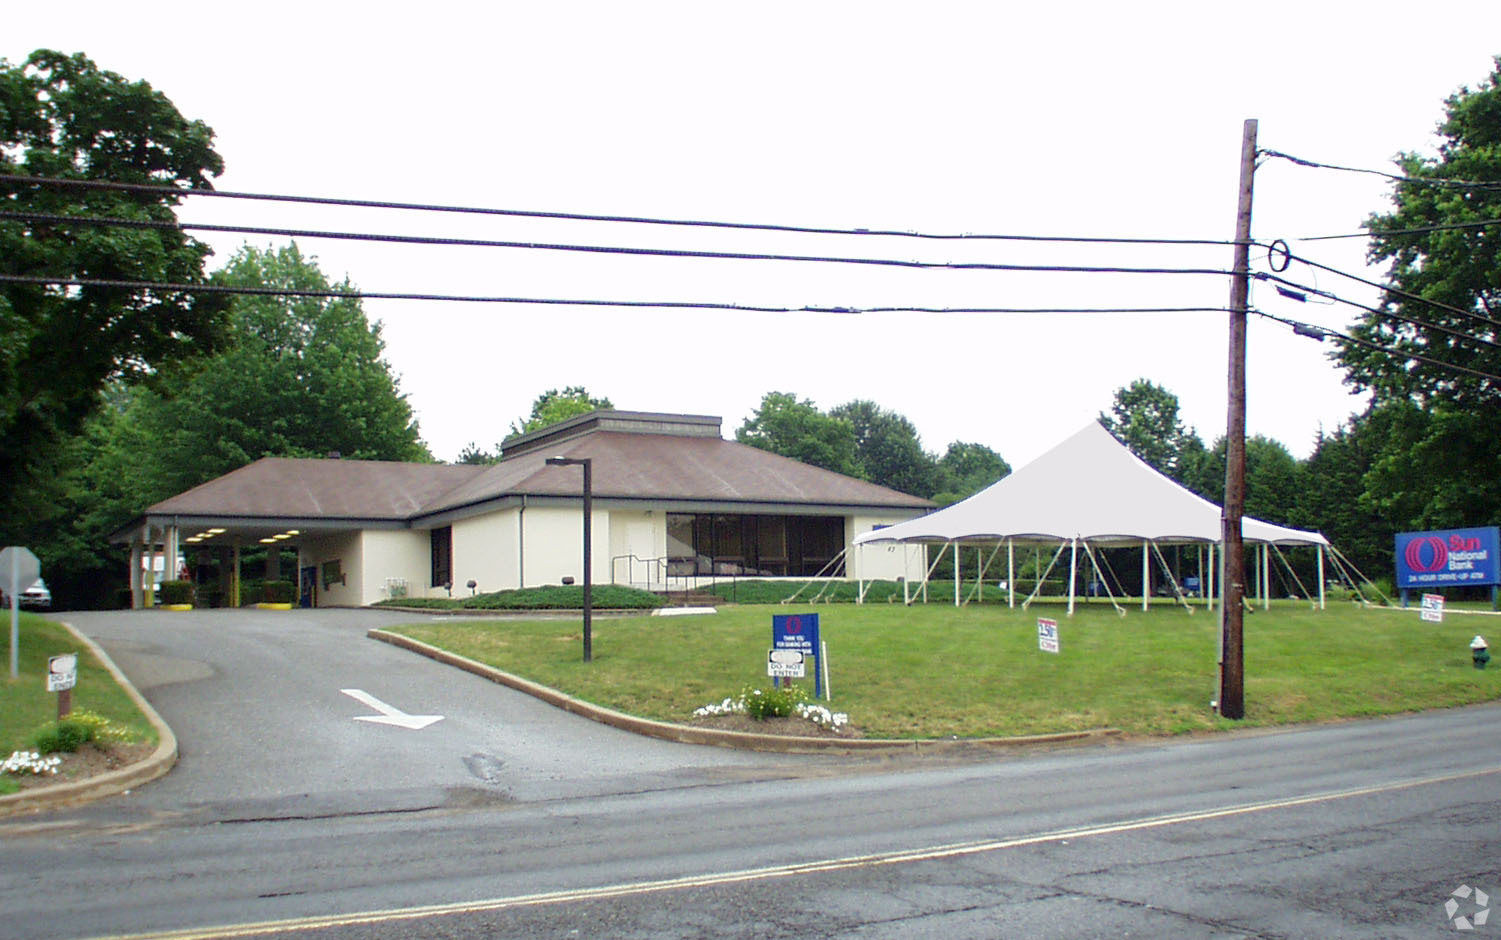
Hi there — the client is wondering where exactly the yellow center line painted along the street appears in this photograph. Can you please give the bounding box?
[87,767,1501,940]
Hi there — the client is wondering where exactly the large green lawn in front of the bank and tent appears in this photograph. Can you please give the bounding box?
[395,602,1501,737]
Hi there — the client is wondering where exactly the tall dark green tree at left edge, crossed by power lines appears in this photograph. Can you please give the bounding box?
[0,50,224,524]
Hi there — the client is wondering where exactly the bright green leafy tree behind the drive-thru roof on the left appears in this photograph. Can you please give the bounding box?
[38,245,431,604]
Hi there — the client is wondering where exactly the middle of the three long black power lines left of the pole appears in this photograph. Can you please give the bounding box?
[0,210,1229,276]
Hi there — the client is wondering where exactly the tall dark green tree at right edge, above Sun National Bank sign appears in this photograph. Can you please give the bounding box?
[1337,57,1501,527]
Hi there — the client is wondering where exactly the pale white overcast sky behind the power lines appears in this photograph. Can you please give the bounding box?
[11,0,1501,465]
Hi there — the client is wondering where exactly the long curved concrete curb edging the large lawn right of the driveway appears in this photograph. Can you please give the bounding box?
[366,629,1120,754]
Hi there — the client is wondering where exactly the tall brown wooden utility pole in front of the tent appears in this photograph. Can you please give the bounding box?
[1219,119,1256,721]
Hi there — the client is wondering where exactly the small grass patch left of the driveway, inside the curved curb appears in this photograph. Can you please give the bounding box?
[0,611,158,793]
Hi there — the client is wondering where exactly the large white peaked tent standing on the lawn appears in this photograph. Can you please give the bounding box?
[854,422,1330,608]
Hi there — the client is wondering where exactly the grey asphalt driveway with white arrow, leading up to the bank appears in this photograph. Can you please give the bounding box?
[49,610,806,818]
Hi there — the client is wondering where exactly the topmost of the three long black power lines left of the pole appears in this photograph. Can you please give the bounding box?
[0,173,1232,246]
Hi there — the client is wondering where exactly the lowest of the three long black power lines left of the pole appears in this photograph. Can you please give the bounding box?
[0,275,1226,314]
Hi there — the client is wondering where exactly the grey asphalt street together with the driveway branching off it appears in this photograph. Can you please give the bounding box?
[0,611,1501,938]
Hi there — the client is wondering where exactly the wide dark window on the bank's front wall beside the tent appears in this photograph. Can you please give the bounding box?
[666,512,845,578]
